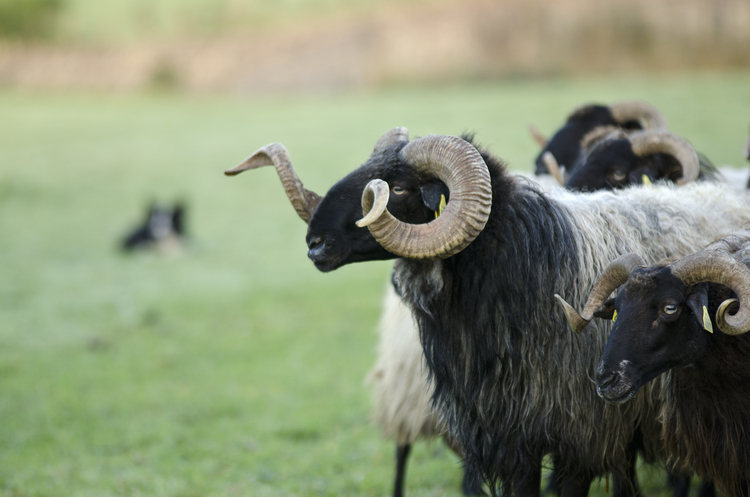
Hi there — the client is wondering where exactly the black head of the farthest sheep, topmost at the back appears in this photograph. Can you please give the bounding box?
[534,105,641,174]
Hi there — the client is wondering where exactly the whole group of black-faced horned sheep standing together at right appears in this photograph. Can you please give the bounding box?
[226,101,750,497]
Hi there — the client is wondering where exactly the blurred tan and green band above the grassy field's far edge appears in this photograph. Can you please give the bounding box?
[0,0,750,91]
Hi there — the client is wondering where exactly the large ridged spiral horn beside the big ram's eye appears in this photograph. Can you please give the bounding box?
[357,135,492,259]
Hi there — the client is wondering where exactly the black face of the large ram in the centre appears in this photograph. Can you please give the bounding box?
[307,142,449,272]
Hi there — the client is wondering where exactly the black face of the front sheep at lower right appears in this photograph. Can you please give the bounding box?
[594,266,716,404]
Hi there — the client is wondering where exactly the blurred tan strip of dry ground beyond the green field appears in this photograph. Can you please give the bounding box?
[0,0,750,91]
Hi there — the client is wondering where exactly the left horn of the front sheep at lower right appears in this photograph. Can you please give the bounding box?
[555,252,646,333]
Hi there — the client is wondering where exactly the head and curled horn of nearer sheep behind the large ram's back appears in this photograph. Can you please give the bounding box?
[565,126,718,191]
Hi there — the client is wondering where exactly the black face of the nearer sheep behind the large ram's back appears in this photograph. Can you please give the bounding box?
[565,138,682,191]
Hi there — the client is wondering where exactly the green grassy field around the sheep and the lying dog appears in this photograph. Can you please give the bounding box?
[0,73,750,497]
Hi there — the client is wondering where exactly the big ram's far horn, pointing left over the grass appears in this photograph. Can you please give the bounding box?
[224,143,321,223]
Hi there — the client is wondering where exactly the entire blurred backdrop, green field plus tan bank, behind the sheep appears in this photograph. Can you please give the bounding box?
[0,0,750,496]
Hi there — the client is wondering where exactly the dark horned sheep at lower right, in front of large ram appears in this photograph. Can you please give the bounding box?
[560,230,750,497]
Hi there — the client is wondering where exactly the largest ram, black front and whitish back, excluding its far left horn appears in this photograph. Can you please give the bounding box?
[290,128,750,497]
